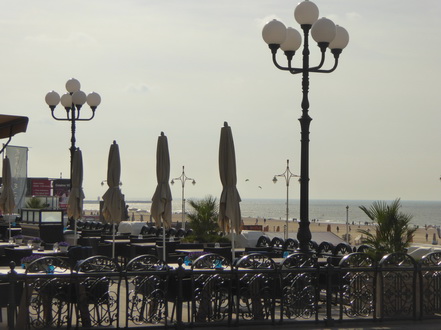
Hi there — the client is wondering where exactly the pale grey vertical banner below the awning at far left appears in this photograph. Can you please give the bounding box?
[5,146,28,209]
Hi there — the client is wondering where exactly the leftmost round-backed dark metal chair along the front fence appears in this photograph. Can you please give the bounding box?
[23,256,76,329]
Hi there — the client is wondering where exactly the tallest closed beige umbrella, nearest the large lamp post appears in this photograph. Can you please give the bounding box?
[219,122,241,258]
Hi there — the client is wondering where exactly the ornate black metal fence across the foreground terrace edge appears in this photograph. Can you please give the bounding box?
[0,252,441,329]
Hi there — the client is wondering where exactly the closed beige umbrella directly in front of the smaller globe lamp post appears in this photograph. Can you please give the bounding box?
[67,148,84,245]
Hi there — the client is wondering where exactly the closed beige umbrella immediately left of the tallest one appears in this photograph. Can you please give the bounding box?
[150,132,172,260]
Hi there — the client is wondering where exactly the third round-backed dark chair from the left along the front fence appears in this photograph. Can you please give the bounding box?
[125,255,168,327]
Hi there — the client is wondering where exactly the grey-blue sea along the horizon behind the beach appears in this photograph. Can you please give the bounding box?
[83,199,441,227]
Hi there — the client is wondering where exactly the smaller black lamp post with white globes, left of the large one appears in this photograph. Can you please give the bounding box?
[46,78,101,184]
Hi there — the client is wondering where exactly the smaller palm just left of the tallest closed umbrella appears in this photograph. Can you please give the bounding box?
[187,196,227,243]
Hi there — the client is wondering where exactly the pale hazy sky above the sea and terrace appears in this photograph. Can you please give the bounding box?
[0,0,441,201]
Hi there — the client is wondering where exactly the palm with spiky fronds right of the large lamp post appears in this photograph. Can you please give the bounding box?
[358,198,416,260]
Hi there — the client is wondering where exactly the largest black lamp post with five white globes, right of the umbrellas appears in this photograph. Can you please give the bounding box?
[262,0,349,252]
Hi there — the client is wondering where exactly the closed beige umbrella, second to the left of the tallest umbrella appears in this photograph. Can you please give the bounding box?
[103,141,124,257]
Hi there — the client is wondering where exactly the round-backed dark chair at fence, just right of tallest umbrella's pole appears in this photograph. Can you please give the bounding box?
[235,253,277,320]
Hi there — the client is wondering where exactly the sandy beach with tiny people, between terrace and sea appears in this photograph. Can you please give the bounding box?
[85,211,441,245]
